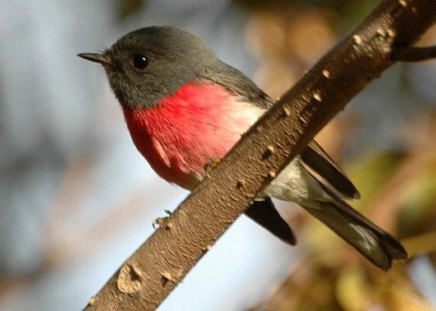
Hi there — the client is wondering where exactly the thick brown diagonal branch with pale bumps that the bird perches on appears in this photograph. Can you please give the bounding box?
[87,0,436,310]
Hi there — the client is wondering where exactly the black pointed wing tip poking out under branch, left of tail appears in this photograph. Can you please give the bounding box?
[245,198,297,245]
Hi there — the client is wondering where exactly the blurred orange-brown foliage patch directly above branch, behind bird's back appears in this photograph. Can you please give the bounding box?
[246,6,338,97]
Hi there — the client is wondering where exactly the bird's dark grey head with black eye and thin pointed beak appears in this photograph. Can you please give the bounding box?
[79,27,220,108]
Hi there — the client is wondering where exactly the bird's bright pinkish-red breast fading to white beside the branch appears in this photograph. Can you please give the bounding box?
[123,82,261,189]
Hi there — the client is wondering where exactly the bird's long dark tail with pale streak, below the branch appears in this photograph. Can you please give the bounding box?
[303,193,407,270]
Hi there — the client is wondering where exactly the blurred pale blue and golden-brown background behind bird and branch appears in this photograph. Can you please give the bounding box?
[0,0,436,311]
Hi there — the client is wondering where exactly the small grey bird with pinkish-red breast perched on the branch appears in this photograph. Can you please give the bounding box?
[78,26,407,270]
